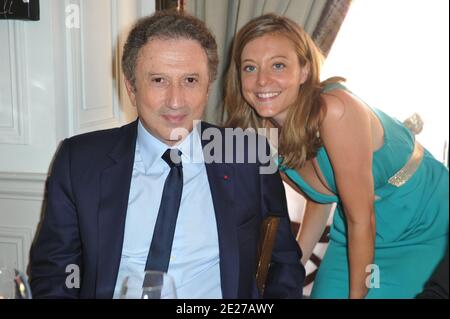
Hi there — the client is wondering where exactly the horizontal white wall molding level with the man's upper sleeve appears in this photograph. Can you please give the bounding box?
[0,172,47,201]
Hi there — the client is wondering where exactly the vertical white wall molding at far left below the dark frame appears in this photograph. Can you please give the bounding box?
[0,21,29,145]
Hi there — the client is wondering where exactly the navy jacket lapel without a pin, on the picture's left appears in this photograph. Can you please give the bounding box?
[96,121,137,298]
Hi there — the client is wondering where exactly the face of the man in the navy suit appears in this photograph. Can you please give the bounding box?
[126,39,210,145]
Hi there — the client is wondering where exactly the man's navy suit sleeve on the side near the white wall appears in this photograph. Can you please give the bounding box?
[29,140,81,298]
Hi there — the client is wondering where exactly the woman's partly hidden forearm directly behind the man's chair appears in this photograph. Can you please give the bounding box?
[297,200,332,265]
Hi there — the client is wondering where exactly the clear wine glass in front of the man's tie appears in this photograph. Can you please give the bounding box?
[120,270,177,299]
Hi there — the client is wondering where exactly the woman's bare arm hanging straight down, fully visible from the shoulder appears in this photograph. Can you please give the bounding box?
[320,91,375,298]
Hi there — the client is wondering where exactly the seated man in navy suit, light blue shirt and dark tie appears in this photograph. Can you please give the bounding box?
[30,12,304,298]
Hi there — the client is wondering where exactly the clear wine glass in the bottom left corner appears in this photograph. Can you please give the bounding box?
[0,266,31,299]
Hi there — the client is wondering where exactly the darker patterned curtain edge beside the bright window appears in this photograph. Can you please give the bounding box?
[312,0,352,56]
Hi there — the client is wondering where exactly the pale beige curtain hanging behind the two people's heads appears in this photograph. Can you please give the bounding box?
[185,0,351,124]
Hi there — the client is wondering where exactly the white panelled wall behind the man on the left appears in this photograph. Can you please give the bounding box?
[0,0,155,270]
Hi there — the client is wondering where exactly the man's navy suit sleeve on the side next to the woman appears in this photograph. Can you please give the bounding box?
[260,139,305,298]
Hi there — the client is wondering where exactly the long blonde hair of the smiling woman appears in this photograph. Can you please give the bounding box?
[225,14,343,168]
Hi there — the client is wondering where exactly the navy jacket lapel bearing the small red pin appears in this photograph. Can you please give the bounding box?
[201,122,239,299]
